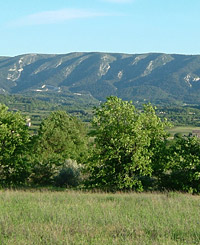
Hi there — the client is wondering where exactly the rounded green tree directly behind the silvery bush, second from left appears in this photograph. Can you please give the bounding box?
[32,111,87,184]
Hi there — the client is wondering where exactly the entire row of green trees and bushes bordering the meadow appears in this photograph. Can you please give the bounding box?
[0,97,200,192]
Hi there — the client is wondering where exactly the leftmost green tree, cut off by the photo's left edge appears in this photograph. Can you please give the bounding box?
[0,104,30,185]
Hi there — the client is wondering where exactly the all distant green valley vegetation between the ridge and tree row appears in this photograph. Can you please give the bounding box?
[0,92,200,130]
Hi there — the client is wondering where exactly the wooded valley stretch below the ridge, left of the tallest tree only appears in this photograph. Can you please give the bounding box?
[0,93,99,130]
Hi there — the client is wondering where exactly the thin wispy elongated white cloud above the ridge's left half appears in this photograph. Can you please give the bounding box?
[9,9,109,26]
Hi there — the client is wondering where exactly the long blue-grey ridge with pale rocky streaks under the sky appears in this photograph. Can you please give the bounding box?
[0,53,200,104]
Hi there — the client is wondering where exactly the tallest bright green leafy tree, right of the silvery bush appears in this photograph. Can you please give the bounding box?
[88,96,167,190]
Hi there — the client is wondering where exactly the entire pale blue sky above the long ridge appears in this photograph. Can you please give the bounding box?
[0,0,200,56]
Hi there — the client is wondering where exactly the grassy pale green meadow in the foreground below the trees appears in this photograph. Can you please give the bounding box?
[0,190,200,245]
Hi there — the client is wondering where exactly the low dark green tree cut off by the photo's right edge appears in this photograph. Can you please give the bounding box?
[162,137,200,193]
